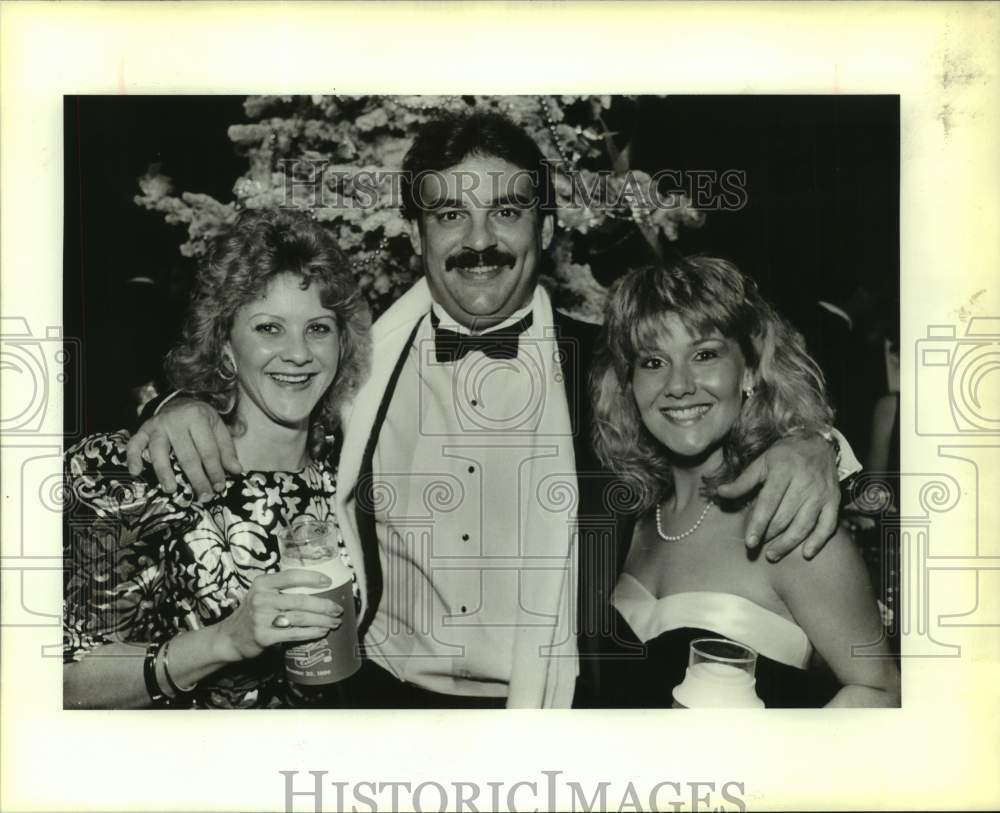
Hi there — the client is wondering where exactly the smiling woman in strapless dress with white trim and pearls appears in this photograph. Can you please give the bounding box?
[592,257,899,707]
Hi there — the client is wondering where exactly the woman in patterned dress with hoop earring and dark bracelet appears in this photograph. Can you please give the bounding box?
[63,210,371,708]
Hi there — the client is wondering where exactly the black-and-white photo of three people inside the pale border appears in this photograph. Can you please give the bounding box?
[64,95,900,708]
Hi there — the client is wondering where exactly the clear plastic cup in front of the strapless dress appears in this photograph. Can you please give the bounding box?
[673,638,764,709]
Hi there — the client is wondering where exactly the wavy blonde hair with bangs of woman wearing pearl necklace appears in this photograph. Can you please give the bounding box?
[591,256,833,509]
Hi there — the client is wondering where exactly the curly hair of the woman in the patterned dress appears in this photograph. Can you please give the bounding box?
[165,209,371,459]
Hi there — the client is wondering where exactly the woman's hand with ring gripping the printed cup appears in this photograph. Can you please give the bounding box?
[217,568,344,662]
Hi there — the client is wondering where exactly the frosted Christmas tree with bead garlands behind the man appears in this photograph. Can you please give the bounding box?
[135,96,704,321]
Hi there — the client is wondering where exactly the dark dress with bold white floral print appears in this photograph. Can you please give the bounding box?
[63,432,359,708]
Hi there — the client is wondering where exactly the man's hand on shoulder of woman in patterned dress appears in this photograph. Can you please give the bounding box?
[126,398,243,500]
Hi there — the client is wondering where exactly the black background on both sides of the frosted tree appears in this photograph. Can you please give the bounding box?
[66,96,899,448]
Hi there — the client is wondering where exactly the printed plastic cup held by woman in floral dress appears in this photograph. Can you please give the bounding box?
[278,519,361,686]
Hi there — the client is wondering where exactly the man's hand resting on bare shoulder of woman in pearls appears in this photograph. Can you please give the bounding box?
[719,435,840,562]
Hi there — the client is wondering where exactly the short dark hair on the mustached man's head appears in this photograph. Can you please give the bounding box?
[400,111,556,220]
